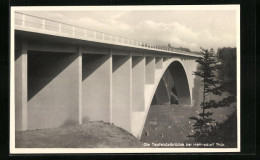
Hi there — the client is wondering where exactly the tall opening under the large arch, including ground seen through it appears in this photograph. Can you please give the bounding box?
[141,61,191,142]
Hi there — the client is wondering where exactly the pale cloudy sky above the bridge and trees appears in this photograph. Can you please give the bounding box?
[23,7,236,51]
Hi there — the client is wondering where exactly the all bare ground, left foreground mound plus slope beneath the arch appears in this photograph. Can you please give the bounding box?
[15,102,235,148]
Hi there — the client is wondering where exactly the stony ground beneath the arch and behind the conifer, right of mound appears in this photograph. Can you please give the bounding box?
[141,102,236,148]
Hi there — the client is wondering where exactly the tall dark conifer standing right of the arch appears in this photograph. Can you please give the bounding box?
[190,48,223,137]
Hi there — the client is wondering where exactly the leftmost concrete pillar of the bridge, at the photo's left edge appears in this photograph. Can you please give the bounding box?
[15,41,28,131]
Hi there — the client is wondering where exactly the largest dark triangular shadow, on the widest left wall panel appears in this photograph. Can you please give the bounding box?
[28,51,77,101]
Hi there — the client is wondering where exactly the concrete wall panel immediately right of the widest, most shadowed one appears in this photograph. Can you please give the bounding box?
[82,54,111,123]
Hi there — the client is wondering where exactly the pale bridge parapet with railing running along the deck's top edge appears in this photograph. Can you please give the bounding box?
[15,12,201,57]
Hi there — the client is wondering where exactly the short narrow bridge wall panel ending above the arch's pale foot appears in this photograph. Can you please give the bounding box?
[132,56,145,111]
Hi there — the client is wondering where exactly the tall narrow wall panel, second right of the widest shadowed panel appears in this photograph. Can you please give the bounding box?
[112,55,131,132]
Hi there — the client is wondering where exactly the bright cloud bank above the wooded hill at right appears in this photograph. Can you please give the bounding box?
[129,20,236,50]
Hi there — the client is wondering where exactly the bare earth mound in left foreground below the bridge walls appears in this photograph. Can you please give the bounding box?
[15,122,142,148]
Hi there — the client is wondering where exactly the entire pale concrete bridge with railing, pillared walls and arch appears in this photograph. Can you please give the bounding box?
[14,12,200,138]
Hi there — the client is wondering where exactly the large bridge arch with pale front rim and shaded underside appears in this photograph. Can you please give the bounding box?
[133,58,192,139]
